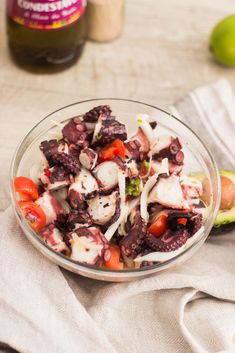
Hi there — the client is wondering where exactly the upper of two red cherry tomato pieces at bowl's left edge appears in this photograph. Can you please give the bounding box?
[14,177,38,200]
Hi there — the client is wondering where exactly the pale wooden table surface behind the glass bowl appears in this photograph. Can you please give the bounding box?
[0,0,235,211]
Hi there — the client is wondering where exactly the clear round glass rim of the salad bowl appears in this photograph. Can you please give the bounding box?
[9,98,221,280]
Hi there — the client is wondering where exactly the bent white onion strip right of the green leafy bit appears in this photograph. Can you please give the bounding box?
[140,158,169,222]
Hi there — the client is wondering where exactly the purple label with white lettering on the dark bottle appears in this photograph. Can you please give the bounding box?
[7,0,86,30]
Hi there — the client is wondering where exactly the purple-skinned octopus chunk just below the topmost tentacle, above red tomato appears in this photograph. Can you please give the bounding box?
[95,117,127,146]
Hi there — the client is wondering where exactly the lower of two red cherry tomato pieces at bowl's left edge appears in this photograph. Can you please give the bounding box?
[18,201,46,232]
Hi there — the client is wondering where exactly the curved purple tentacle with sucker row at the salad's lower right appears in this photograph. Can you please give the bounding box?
[145,229,190,252]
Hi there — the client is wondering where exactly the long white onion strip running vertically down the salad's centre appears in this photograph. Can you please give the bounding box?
[104,170,128,241]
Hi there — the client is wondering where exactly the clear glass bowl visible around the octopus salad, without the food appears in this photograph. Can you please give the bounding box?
[10,99,220,282]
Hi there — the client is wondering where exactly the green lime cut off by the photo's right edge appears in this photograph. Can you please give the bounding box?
[210,15,235,66]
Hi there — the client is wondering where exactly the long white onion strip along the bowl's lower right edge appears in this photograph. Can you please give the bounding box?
[134,227,204,263]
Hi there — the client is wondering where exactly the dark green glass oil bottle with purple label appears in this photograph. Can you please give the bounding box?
[7,0,86,71]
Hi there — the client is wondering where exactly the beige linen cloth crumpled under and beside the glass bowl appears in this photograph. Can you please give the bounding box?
[0,80,235,353]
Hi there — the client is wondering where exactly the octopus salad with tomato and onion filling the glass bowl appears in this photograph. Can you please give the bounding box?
[14,105,206,270]
